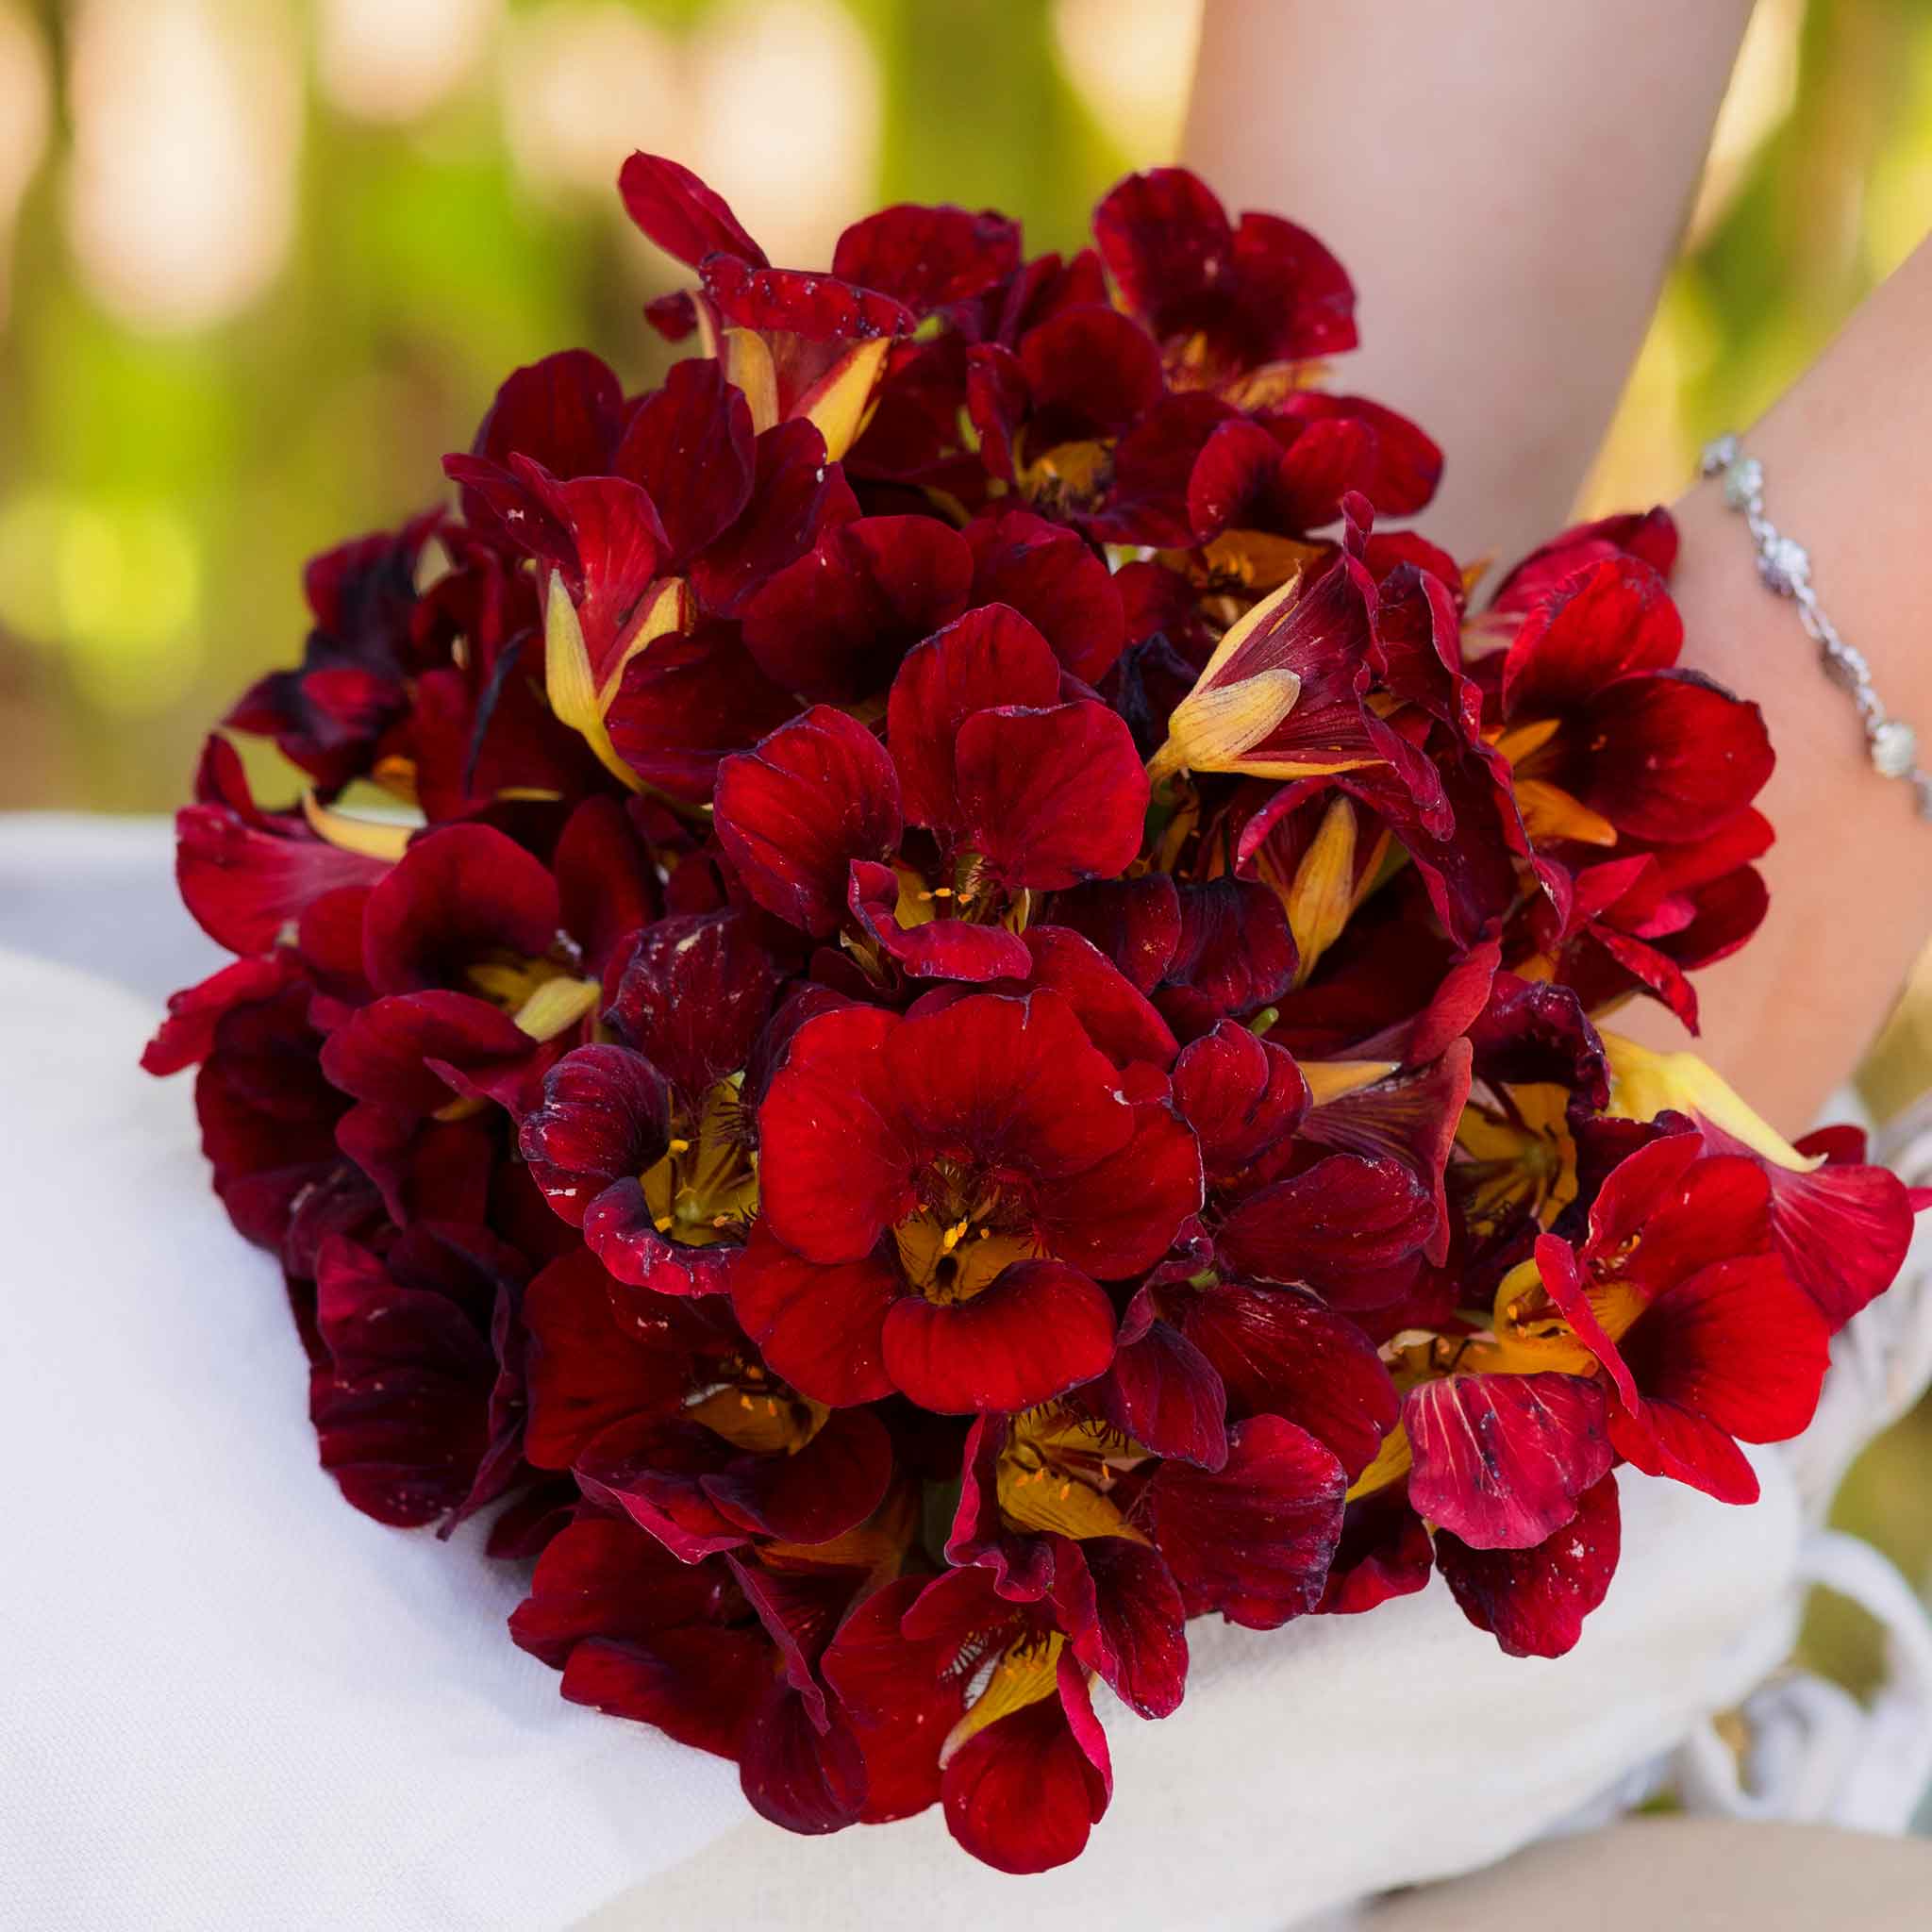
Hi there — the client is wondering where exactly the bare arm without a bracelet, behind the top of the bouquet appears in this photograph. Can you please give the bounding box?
[1184,0,1750,562]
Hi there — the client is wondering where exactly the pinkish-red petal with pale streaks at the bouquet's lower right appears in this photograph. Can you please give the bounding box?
[1403,1374,1611,1549]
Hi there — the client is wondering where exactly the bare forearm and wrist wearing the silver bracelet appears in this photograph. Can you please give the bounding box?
[1617,243,1932,1132]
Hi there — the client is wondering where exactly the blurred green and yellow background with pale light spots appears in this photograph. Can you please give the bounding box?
[0,0,1932,1677]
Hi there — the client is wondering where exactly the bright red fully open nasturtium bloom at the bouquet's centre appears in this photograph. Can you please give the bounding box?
[732,991,1202,1414]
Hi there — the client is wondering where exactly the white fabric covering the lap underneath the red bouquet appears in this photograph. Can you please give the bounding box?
[0,817,1916,1932]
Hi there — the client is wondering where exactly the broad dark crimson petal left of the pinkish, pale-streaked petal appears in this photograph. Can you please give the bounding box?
[1148,1416,1349,1631]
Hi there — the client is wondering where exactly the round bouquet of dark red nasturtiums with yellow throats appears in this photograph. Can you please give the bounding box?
[147,155,1921,1873]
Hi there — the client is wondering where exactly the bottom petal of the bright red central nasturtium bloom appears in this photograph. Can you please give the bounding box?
[885,1261,1115,1416]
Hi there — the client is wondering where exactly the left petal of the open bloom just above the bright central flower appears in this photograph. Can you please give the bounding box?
[717,706,900,937]
